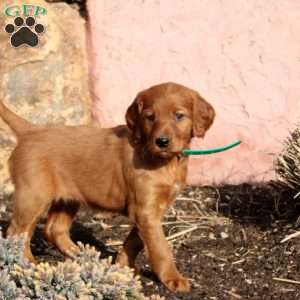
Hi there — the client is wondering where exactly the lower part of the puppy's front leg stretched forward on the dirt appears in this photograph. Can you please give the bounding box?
[136,213,190,292]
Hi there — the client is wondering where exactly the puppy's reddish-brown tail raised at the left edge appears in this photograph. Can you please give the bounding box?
[0,100,36,137]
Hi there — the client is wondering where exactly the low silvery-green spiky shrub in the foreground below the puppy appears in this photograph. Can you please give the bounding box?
[0,230,162,300]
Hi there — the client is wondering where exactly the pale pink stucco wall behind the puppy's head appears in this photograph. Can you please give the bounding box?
[88,0,300,184]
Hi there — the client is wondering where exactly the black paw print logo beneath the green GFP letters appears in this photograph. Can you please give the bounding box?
[5,17,45,48]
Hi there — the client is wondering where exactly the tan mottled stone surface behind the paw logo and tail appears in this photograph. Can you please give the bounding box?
[0,0,91,192]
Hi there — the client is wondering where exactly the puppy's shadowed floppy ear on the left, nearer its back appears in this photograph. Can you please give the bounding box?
[125,93,143,139]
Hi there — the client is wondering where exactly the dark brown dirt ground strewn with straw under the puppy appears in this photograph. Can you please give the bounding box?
[0,184,300,300]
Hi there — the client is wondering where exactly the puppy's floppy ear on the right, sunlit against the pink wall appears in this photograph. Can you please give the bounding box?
[192,92,215,137]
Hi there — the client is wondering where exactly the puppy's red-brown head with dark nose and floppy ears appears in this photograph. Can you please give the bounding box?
[126,83,215,158]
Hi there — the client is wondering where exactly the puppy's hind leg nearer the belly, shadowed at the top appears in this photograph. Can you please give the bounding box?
[45,200,80,258]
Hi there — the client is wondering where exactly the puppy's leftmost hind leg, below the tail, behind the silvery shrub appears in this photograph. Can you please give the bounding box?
[7,189,51,263]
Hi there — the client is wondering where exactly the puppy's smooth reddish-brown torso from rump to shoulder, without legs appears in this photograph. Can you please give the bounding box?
[9,126,129,209]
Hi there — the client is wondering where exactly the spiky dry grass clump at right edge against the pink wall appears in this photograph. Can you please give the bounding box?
[275,127,300,197]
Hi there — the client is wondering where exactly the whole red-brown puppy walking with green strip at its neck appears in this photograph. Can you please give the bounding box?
[0,83,215,291]
